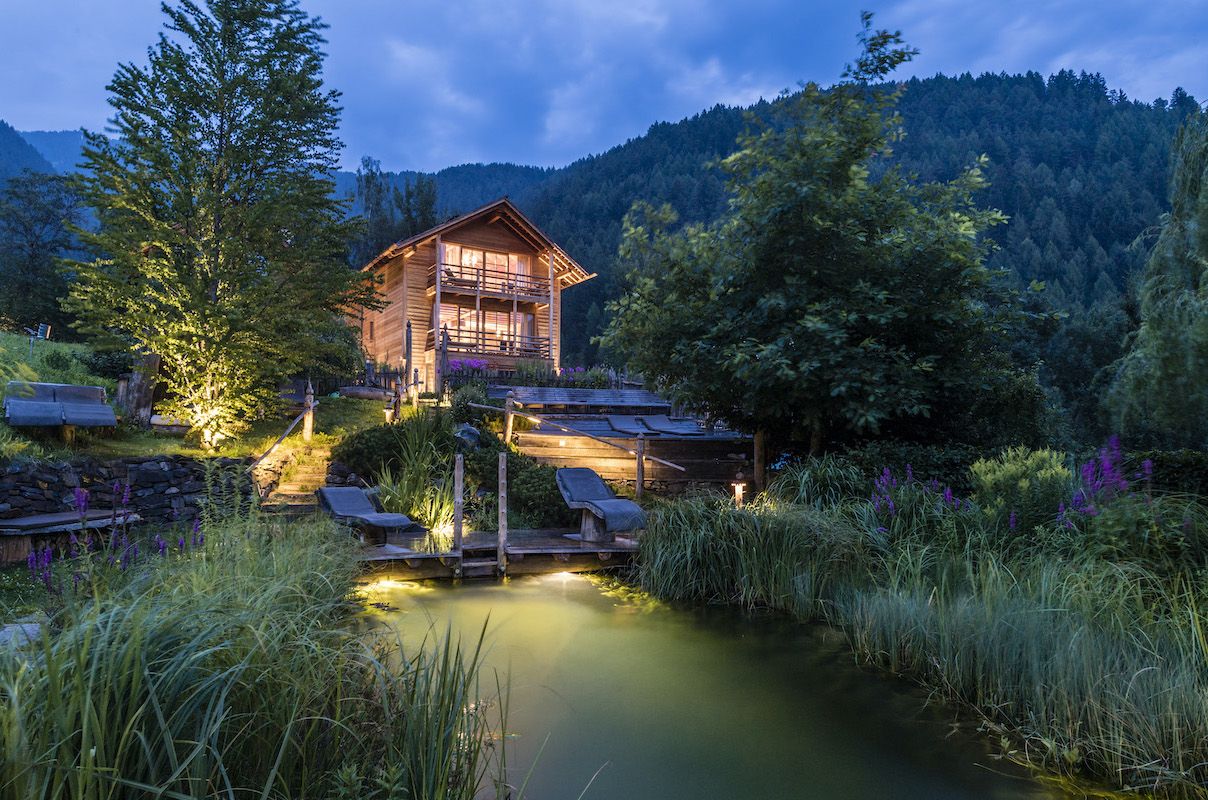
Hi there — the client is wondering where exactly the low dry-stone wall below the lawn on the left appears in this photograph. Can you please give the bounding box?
[0,456,289,527]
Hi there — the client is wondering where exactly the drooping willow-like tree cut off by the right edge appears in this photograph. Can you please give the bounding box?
[1111,112,1208,447]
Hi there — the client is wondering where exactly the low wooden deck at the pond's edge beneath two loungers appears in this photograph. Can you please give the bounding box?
[352,529,638,579]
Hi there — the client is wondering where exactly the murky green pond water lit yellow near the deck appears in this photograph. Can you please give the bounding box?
[371,574,1055,800]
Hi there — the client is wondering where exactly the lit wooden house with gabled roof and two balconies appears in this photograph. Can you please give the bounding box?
[356,198,594,390]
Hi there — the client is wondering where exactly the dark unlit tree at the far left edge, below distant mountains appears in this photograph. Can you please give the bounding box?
[0,170,80,330]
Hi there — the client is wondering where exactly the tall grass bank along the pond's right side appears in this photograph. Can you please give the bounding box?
[638,475,1208,798]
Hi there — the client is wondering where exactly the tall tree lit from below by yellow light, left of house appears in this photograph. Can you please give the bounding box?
[70,0,376,446]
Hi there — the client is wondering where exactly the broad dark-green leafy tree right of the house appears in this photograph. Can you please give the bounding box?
[604,15,1003,451]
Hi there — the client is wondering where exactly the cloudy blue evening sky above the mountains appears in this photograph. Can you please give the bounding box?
[0,0,1208,170]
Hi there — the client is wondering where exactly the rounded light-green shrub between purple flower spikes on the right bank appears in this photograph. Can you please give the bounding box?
[969,447,1074,532]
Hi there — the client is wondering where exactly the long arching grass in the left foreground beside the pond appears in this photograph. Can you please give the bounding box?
[0,516,501,800]
